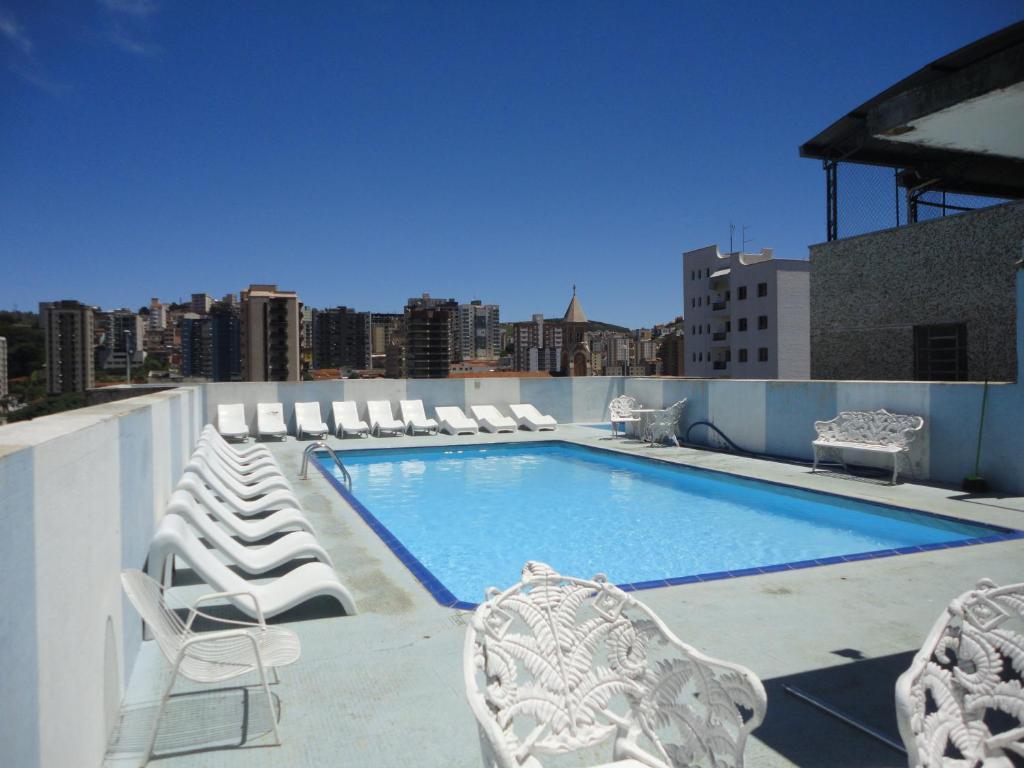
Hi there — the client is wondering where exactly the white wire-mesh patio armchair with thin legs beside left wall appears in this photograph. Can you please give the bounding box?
[121,570,302,766]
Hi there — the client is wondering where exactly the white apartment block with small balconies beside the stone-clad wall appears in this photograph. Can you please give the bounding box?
[683,246,811,379]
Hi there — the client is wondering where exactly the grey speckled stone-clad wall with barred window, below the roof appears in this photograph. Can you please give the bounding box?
[811,202,1024,381]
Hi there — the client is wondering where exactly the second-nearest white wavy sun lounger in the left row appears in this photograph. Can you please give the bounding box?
[165,490,334,573]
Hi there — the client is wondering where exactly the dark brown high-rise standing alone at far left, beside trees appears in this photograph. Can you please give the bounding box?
[39,301,95,394]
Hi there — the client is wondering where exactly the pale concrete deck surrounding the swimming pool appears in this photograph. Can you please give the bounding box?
[106,425,1024,768]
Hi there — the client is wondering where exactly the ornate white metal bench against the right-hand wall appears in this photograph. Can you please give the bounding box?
[811,409,925,484]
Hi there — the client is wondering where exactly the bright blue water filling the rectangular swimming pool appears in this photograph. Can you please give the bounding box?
[318,442,1007,602]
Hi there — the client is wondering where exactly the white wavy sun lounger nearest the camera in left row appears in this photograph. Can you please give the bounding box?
[148,515,356,618]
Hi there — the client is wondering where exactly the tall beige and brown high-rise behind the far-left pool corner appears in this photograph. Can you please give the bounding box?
[242,285,301,381]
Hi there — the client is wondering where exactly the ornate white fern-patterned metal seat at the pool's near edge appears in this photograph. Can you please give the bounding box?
[463,562,767,768]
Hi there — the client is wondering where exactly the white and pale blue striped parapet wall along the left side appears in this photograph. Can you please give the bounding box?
[0,387,203,768]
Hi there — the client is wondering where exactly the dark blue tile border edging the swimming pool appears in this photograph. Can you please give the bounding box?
[312,440,1024,610]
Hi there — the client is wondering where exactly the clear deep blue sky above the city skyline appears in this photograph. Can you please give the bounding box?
[0,0,1024,327]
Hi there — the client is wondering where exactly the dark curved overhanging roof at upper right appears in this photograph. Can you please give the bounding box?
[800,22,1024,198]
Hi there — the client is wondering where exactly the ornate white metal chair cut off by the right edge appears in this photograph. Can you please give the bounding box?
[896,579,1024,768]
